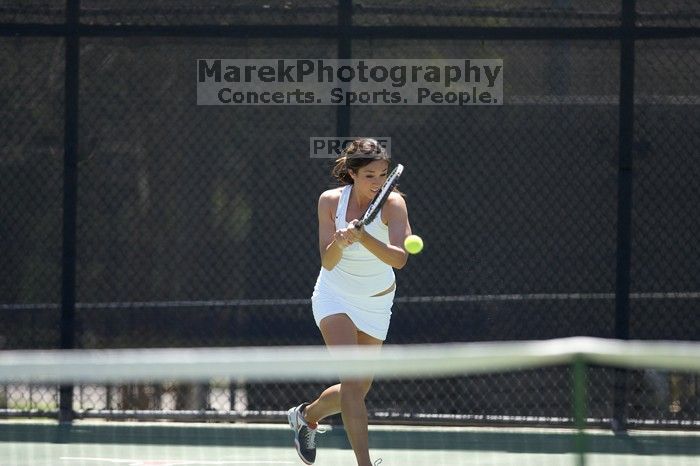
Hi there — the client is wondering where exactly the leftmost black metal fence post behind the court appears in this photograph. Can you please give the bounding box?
[58,0,80,423]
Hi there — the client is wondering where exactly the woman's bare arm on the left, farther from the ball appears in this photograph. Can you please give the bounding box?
[318,189,351,270]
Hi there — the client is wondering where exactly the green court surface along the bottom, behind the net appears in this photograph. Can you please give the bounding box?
[0,421,700,466]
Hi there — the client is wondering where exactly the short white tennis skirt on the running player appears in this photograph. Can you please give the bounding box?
[311,286,396,341]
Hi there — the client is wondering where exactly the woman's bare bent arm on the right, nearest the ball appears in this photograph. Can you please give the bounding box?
[360,192,411,269]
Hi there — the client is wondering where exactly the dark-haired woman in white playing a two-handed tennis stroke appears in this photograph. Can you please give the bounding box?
[287,138,411,466]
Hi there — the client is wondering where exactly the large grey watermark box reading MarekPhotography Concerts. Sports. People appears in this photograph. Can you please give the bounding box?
[197,58,503,106]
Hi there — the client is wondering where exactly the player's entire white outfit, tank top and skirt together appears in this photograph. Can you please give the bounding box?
[311,185,396,340]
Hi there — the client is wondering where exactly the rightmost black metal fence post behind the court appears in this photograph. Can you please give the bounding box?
[611,0,636,432]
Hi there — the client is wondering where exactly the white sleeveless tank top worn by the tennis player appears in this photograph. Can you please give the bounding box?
[316,185,395,296]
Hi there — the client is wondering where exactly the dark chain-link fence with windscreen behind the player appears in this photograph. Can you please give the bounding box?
[0,0,700,425]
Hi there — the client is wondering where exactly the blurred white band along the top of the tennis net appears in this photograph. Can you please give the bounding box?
[0,337,700,384]
